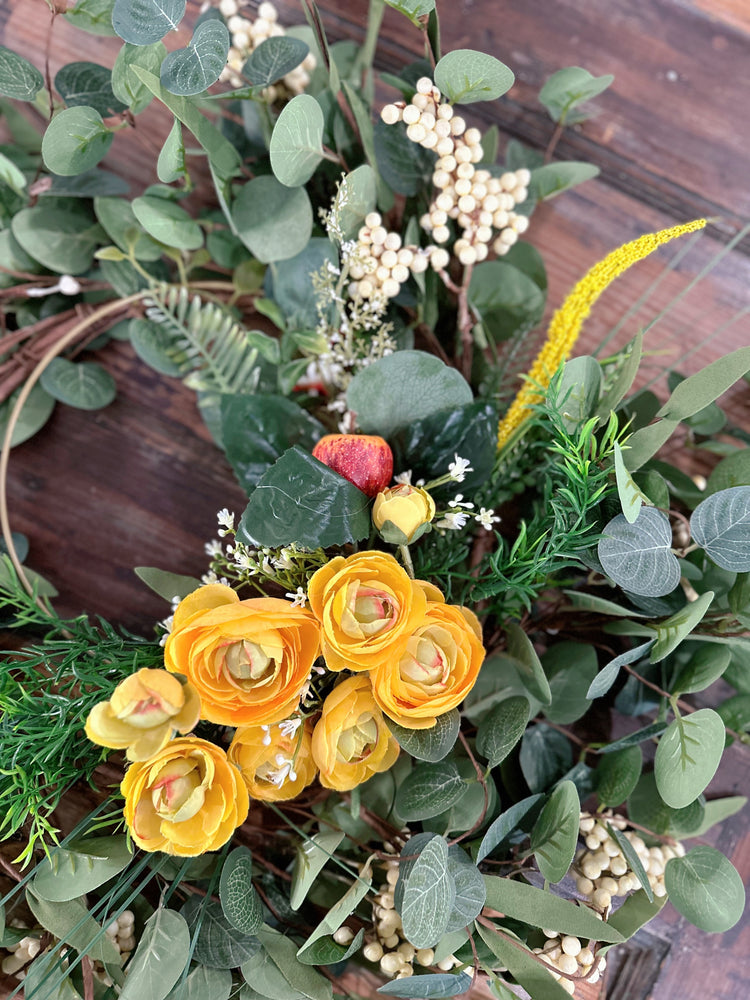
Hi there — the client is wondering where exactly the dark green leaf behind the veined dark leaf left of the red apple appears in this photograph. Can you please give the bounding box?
[221,394,325,493]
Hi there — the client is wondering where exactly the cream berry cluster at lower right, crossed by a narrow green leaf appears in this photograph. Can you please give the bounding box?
[575,813,685,910]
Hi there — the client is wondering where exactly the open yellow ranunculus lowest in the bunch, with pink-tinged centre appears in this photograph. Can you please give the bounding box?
[120,736,249,858]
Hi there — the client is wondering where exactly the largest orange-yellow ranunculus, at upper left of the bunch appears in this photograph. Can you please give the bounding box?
[164,584,319,726]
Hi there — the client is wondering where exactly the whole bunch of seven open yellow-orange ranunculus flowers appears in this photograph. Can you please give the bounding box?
[86,552,484,857]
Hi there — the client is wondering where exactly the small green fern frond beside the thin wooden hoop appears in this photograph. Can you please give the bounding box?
[146,285,278,394]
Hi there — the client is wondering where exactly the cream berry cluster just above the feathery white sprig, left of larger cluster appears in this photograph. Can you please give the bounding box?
[349,212,448,299]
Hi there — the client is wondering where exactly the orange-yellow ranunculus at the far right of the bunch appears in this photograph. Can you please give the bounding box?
[370,601,484,729]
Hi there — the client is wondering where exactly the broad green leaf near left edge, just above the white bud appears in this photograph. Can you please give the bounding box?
[11,202,104,274]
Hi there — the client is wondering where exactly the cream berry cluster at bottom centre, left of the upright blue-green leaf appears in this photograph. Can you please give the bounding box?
[362,859,463,979]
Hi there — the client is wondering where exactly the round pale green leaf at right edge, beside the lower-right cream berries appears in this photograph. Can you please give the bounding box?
[664,845,745,934]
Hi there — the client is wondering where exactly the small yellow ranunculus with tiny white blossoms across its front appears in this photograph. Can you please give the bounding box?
[227,721,318,802]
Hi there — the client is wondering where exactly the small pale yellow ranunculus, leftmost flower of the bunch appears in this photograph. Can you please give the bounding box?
[86,667,201,760]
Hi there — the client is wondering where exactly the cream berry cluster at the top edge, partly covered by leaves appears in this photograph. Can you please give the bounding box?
[219,0,316,95]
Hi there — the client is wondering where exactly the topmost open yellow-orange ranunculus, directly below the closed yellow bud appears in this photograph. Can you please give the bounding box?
[308,552,427,671]
